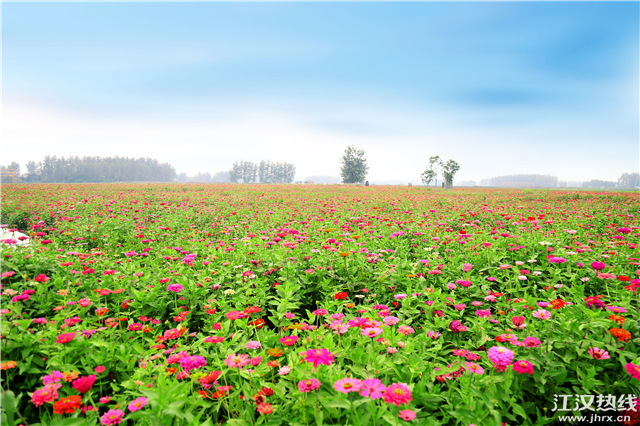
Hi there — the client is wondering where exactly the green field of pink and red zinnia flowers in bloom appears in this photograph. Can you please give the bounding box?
[0,184,640,426]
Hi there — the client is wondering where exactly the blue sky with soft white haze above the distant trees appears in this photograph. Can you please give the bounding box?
[1,2,640,182]
